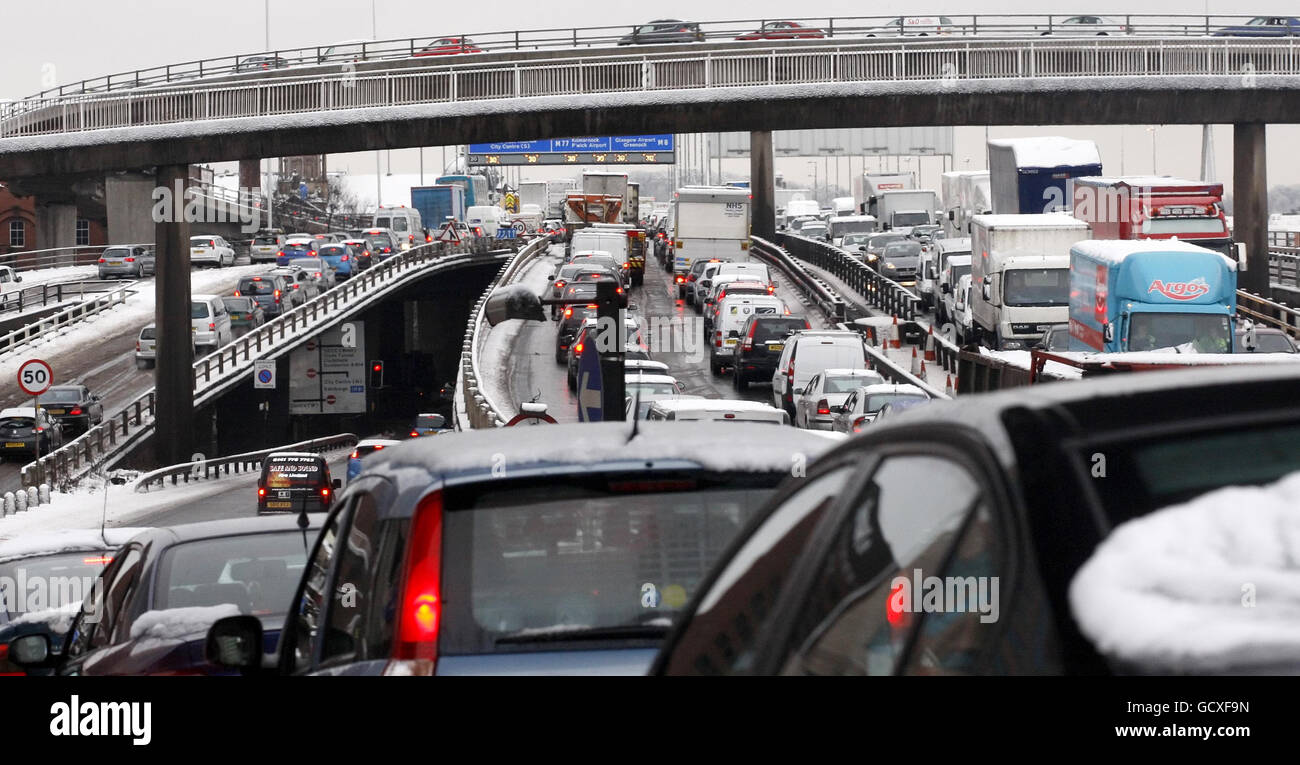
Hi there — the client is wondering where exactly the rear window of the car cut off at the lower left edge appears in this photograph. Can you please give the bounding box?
[0,550,113,621]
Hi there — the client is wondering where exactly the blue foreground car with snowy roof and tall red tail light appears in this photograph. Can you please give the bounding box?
[198,423,833,675]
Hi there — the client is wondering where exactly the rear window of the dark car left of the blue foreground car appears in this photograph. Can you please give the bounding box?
[152,531,313,615]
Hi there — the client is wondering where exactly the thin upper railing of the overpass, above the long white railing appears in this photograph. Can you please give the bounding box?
[7,14,1289,101]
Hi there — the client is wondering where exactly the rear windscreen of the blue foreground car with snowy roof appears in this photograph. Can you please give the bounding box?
[438,470,781,654]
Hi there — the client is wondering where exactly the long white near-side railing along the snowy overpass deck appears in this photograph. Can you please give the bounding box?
[0,35,1300,139]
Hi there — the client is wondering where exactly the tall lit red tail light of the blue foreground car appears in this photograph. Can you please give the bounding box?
[393,492,442,674]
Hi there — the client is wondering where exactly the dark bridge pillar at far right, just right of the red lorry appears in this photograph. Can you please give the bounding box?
[1232,122,1271,297]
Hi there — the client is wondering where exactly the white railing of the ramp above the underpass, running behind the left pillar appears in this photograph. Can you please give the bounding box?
[22,241,499,488]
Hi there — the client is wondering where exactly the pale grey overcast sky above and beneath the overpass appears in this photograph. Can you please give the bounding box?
[0,0,1300,202]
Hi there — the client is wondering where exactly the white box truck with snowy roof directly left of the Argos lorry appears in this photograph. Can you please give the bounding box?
[971,212,1088,350]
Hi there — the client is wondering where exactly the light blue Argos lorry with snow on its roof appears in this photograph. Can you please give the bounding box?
[1070,239,1236,354]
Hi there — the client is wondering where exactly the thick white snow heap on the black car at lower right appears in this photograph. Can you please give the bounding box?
[1070,474,1300,673]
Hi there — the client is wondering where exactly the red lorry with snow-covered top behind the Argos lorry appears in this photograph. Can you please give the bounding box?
[1070,176,1235,258]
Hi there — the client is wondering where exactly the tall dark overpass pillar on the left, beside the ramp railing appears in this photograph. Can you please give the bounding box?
[153,165,195,466]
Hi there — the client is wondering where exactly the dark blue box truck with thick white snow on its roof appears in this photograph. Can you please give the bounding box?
[988,137,1101,215]
